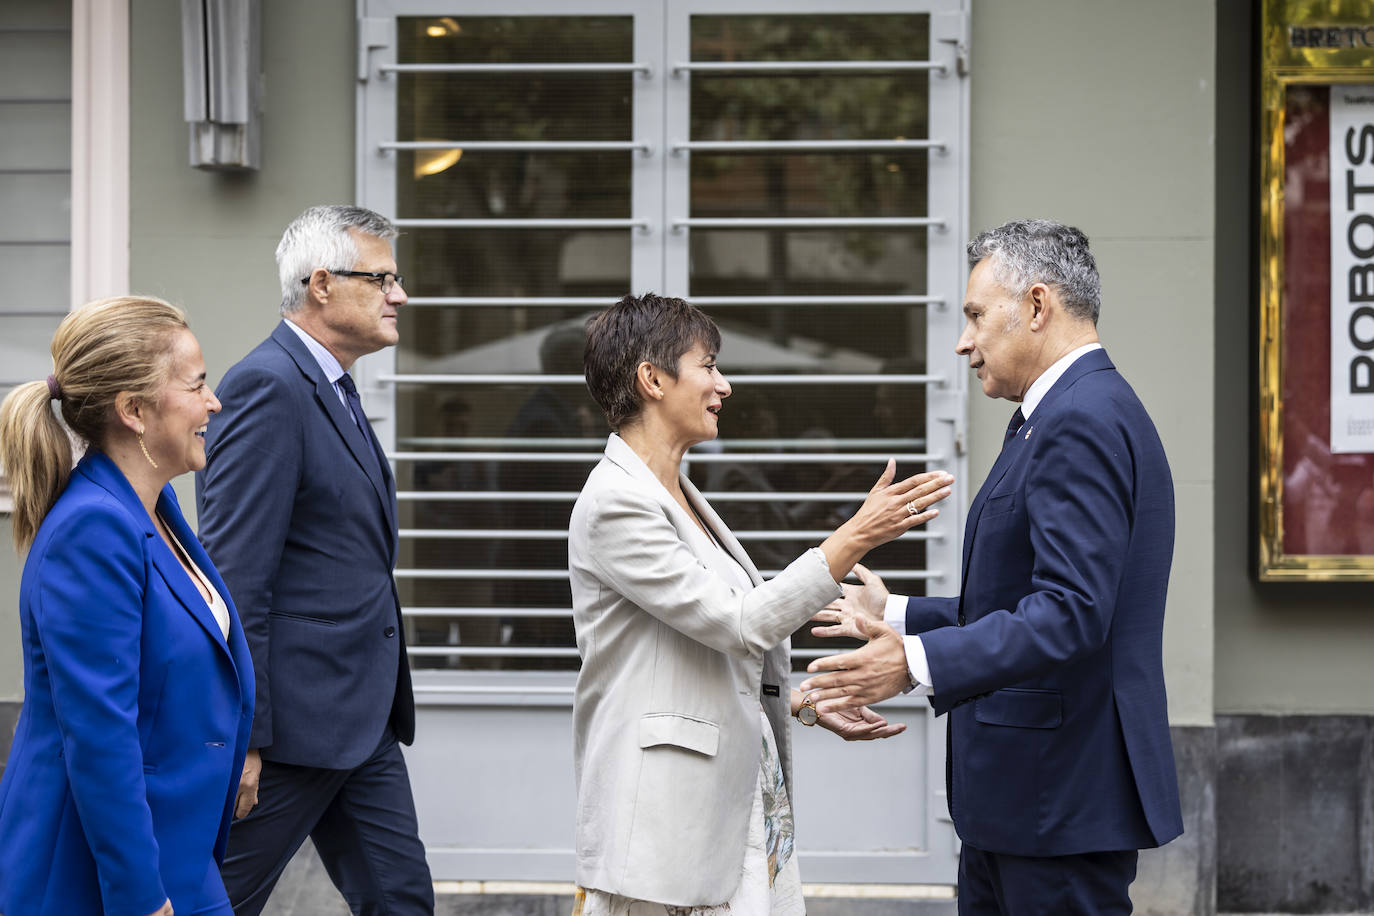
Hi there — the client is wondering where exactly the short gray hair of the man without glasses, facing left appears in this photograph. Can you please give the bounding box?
[969,220,1102,324]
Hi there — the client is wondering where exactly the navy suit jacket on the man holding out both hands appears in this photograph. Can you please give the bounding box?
[907,350,1183,856]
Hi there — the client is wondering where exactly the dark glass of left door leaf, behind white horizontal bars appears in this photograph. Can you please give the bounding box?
[396,16,635,669]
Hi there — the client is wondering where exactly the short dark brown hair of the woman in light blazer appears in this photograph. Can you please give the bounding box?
[583,293,720,430]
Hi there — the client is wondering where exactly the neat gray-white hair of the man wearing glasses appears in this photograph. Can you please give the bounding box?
[276,205,398,314]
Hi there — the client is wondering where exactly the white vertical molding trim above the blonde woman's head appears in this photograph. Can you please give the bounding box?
[71,0,129,308]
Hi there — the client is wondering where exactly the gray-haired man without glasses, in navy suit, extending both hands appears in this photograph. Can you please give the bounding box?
[802,220,1183,916]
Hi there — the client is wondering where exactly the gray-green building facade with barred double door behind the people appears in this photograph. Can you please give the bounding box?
[0,0,1374,913]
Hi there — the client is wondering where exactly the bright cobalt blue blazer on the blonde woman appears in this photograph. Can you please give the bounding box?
[0,452,253,916]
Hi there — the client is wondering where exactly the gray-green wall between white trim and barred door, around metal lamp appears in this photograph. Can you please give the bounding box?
[129,0,357,518]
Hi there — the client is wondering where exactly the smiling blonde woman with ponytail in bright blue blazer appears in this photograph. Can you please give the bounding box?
[0,298,253,916]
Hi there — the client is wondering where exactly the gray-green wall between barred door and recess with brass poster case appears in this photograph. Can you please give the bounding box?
[967,0,1216,725]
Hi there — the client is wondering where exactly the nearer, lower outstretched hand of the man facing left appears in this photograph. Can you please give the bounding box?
[801,614,911,714]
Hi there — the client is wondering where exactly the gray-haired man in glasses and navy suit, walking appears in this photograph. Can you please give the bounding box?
[196,206,434,916]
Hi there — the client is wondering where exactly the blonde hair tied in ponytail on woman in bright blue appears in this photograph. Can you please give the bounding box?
[0,297,187,552]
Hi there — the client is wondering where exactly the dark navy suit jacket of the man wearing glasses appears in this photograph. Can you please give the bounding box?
[196,323,415,769]
